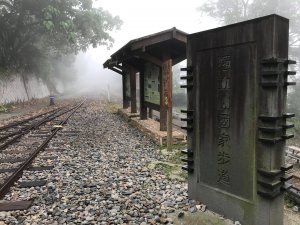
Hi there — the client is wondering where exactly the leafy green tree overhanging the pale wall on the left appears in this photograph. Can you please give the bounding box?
[0,0,122,76]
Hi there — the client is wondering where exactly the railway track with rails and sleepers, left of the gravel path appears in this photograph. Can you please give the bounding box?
[0,101,84,211]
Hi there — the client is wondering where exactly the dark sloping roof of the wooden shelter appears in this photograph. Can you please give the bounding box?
[103,27,187,72]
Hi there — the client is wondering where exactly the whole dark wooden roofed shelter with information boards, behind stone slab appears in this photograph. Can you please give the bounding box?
[103,27,187,131]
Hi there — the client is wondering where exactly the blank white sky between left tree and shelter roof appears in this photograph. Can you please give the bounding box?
[95,0,217,59]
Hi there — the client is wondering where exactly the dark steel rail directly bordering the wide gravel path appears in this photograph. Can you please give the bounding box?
[0,101,85,199]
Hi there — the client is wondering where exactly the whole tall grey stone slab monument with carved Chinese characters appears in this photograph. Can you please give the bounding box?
[187,15,289,225]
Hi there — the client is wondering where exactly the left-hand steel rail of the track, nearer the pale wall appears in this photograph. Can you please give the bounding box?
[0,106,76,152]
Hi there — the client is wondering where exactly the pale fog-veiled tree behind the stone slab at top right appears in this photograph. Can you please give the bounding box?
[197,0,300,116]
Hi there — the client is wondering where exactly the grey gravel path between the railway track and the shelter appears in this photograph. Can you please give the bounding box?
[0,100,197,225]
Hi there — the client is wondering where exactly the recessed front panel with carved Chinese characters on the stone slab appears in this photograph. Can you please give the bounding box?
[197,44,256,201]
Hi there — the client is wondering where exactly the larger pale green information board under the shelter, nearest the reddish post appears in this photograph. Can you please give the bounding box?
[144,63,161,105]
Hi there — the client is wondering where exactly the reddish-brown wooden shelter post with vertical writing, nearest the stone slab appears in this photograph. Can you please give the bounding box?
[161,59,173,151]
